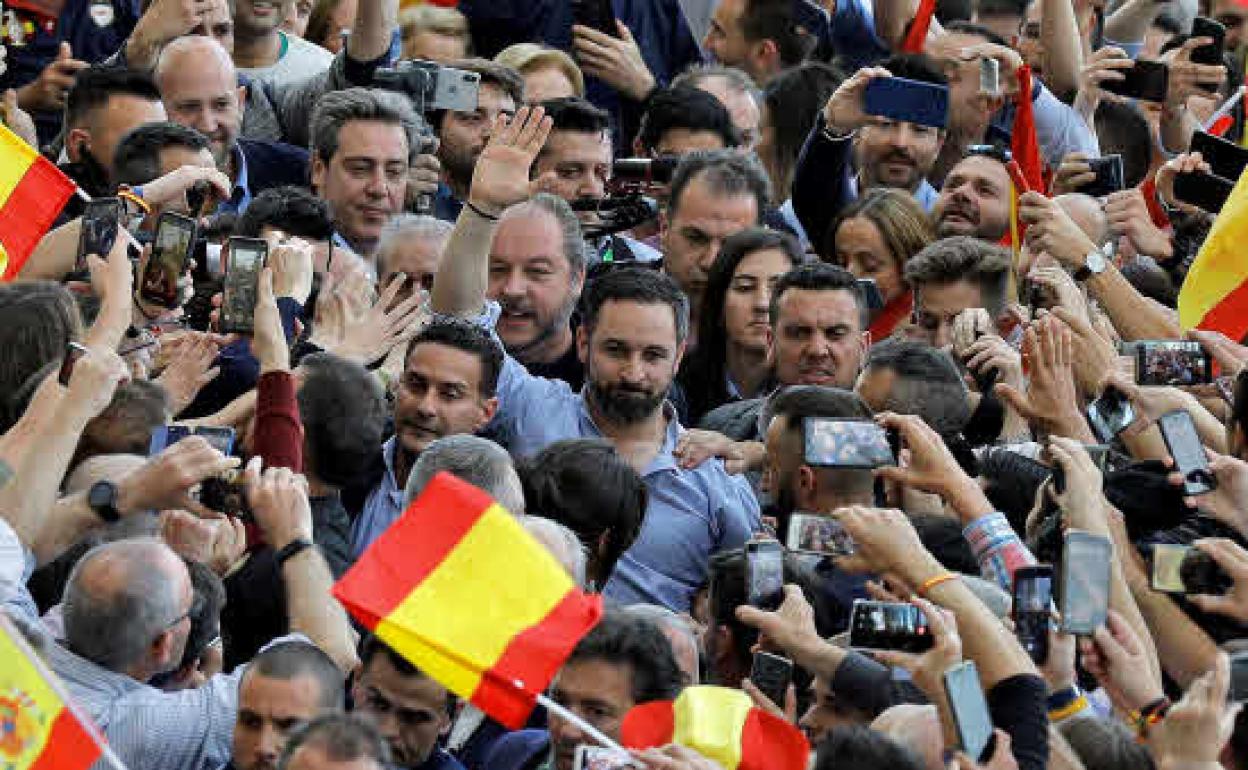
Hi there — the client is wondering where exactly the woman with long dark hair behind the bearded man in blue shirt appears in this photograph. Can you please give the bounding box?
[678,227,804,426]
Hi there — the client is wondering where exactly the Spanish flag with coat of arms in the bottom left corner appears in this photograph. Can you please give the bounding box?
[0,613,104,770]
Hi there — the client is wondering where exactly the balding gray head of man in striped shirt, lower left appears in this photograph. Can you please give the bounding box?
[61,538,181,671]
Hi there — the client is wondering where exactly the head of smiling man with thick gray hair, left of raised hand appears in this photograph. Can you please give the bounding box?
[312,89,422,258]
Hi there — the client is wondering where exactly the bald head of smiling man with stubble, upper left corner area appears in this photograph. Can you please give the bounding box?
[156,35,246,168]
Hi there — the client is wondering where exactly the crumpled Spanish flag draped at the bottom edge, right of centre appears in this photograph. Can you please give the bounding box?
[620,686,810,770]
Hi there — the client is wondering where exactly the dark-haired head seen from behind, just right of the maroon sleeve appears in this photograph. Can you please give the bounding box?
[297,353,389,488]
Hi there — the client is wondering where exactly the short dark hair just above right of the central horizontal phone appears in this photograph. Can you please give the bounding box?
[866,338,971,434]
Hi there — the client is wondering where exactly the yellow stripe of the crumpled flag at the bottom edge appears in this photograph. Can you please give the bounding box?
[671,688,754,770]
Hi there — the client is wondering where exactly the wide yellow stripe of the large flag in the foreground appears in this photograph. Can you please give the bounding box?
[376,503,574,698]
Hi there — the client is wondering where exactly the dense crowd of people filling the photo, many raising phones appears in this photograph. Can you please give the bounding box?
[0,0,1248,770]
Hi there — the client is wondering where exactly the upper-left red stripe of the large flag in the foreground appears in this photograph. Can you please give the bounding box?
[333,474,494,630]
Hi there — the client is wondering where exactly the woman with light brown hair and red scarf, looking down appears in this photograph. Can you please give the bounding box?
[824,187,936,342]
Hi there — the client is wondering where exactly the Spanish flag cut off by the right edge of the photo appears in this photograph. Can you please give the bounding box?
[1178,167,1248,342]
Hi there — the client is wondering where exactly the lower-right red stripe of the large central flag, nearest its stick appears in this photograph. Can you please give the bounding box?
[472,589,603,730]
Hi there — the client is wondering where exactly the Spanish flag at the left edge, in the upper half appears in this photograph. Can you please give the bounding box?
[0,124,75,281]
